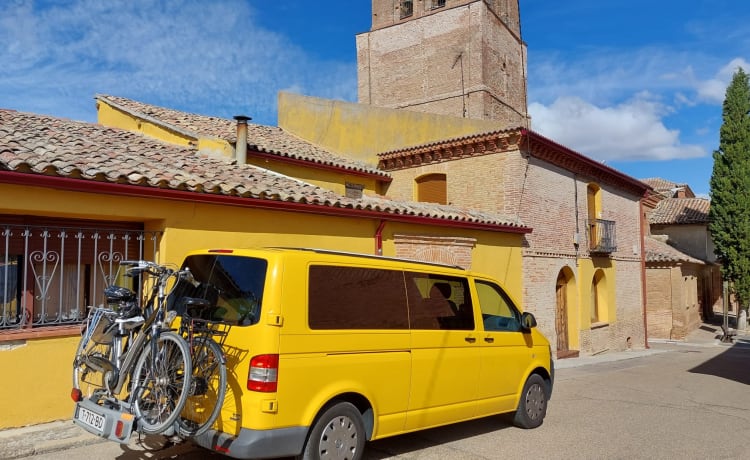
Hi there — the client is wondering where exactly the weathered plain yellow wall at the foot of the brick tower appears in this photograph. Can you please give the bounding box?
[278,92,502,165]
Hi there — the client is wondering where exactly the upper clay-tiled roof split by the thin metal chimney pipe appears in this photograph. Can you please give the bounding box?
[96,94,390,178]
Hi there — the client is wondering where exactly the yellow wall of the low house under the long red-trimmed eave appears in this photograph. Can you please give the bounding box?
[0,184,522,429]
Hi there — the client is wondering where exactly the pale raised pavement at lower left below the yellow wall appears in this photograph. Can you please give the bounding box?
[0,420,107,460]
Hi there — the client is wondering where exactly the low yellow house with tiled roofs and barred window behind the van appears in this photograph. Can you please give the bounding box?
[0,102,531,429]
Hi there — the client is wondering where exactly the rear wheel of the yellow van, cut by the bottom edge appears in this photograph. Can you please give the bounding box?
[298,402,366,460]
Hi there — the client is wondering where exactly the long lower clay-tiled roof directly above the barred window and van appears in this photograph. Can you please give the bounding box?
[0,110,528,231]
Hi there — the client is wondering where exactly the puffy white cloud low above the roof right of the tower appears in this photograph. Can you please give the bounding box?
[529,94,706,161]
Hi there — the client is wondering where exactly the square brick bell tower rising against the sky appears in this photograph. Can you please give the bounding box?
[357,0,528,128]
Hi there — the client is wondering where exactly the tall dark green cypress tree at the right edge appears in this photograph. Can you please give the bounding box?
[709,69,750,308]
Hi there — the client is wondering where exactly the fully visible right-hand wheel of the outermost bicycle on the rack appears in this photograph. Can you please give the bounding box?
[131,332,192,434]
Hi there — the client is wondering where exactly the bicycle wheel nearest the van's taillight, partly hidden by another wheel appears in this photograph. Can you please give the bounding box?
[177,336,227,437]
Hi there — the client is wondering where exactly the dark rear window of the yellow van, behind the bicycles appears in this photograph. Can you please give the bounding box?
[170,254,268,326]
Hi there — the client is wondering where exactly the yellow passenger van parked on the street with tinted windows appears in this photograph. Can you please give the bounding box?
[173,248,554,459]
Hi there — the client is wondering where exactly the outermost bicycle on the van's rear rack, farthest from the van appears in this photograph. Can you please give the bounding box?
[71,261,192,436]
